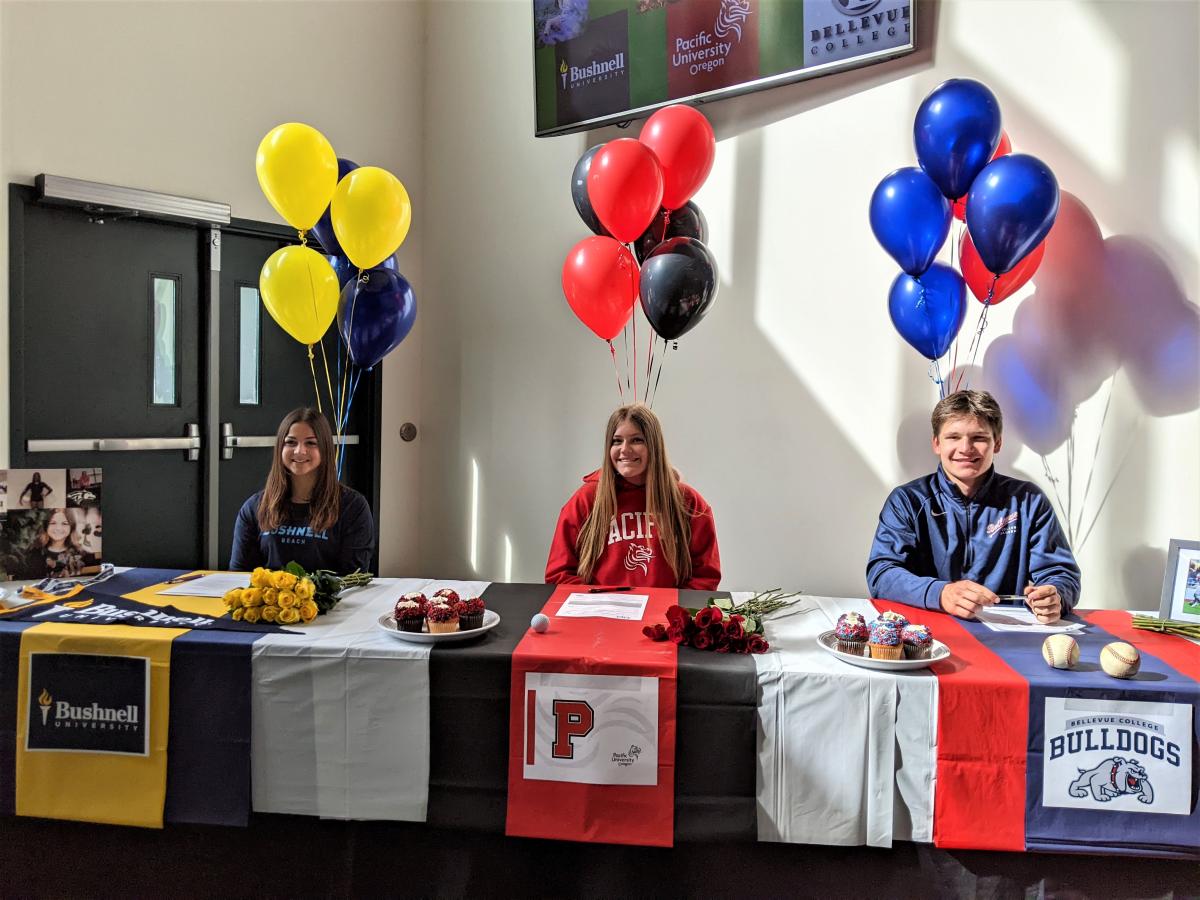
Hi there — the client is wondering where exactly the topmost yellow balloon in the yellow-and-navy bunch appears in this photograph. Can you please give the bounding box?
[254,122,337,232]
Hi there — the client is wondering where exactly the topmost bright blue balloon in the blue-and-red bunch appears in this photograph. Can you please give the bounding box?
[912,78,1000,200]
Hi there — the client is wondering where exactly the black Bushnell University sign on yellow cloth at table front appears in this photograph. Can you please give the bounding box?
[25,653,150,756]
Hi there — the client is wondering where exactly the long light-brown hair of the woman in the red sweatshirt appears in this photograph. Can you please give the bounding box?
[576,403,694,584]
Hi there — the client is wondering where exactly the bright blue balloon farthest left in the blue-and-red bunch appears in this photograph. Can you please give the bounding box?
[871,166,950,276]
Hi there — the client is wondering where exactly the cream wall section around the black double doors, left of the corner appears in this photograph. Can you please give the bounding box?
[0,0,428,572]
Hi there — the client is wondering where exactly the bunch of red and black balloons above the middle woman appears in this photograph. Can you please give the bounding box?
[563,106,719,395]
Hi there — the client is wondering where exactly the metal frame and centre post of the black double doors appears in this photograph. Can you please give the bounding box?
[8,181,383,569]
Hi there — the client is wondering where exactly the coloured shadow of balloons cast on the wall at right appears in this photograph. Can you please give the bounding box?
[984,192,1200,455]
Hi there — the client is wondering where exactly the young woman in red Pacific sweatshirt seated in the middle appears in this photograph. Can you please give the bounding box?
[546,404,721,590]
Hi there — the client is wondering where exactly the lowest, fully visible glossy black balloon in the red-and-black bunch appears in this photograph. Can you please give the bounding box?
[640,238,718,341]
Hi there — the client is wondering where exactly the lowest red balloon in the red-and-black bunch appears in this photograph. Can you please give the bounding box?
[563,235,637,341]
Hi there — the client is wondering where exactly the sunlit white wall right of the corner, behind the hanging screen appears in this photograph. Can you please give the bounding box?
[420,0,1200,608]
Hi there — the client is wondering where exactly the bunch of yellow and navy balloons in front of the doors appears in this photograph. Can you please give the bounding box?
[254,122,416,374]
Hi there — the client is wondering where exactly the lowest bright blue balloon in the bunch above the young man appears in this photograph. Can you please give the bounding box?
[888,263,967,359]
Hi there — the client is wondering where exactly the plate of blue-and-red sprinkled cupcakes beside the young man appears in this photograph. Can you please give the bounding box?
[817,610,950,672]
